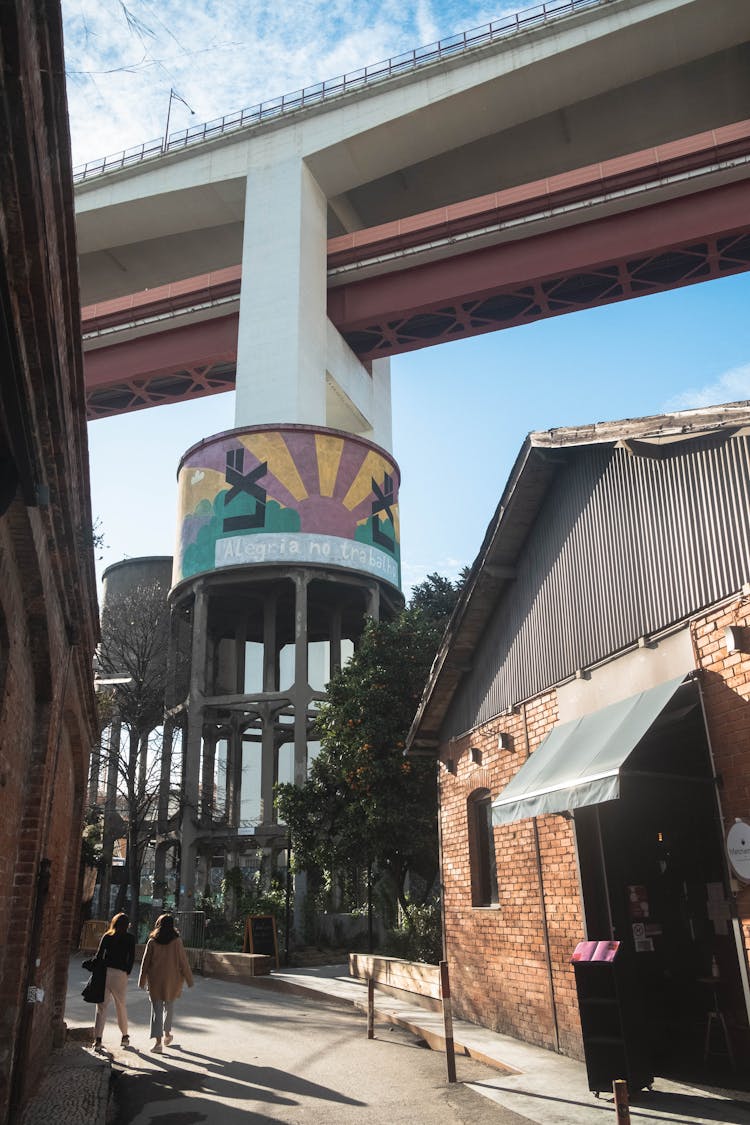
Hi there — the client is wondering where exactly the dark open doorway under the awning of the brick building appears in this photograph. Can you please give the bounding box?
[576,683,750,1087]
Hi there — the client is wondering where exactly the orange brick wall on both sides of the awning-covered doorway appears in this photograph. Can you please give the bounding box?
[440,596,750,1058]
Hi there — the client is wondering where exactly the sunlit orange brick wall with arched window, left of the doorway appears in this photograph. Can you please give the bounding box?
[440,693,582,1056]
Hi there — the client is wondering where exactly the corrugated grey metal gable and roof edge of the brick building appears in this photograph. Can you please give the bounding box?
[407,402,750,746]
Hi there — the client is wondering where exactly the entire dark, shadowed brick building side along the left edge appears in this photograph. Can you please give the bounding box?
[0,0,98,1123]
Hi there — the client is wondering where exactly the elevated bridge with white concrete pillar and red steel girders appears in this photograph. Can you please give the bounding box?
[76,0,750,429]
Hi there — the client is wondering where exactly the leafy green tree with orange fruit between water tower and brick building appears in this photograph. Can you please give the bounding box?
[278,575,460,940]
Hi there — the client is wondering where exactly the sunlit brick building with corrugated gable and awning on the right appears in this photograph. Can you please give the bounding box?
[409,403,750,1088]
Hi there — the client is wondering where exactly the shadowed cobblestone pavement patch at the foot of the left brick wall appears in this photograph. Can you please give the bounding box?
[21,1040,111,1125]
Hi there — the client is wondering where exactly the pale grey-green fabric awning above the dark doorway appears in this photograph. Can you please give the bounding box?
[493,676,685,825]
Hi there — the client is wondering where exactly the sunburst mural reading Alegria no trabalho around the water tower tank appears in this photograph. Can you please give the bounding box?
[173,425,400,588]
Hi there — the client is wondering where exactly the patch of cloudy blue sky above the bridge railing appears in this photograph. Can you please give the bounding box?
[63,0,523,164]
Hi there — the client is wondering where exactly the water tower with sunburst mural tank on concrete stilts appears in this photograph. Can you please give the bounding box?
[168,424,403,908]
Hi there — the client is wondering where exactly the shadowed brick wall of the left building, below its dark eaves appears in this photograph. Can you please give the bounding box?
[0,502,91,1122]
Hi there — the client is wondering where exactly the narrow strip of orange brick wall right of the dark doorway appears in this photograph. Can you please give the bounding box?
[692,597,750,967]
